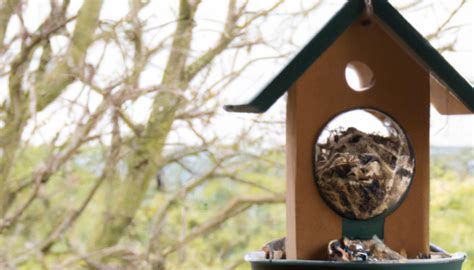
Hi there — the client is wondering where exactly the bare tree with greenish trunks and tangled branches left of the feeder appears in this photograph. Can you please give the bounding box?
[0,0,292,268]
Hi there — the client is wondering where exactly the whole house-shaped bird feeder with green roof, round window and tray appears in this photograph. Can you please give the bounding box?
[225,0,474,269]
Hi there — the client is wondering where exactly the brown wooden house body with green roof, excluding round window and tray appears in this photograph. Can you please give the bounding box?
[225,0,474,259]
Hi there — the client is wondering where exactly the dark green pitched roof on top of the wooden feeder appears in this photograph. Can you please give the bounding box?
[224,0,474,113]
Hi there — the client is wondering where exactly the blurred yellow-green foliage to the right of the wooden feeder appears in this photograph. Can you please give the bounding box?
[430,148,474,270]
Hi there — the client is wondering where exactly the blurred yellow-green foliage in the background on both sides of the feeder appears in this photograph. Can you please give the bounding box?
[0,147,474,270]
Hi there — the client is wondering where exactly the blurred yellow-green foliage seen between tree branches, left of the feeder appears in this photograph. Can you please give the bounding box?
[0,146,285,269]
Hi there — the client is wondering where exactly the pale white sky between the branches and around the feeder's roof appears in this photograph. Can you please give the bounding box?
[0,0,474,149]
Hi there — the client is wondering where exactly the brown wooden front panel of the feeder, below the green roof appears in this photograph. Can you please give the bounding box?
[287,16,430,259]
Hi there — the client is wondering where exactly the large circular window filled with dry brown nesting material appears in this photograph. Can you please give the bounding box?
[314,109,415,220]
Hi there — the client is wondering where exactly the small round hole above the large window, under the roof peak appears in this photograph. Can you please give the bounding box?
[345,61,375,92]
